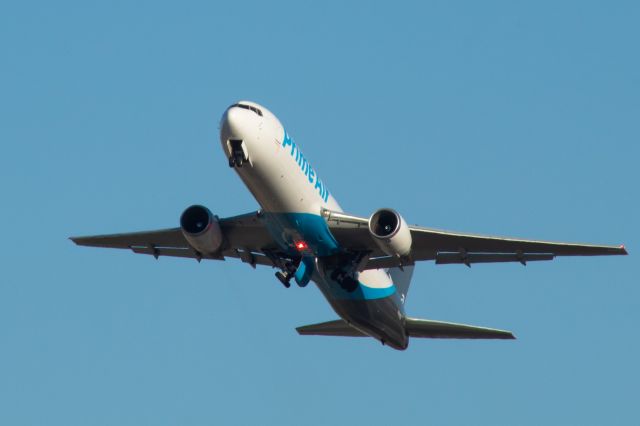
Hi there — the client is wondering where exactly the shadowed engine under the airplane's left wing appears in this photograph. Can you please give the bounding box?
[180,205,223,254]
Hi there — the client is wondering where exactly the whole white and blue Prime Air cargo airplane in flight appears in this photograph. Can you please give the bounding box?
[71,101,627,350]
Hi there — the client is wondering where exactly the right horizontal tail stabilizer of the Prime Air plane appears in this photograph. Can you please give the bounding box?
[406,318,515,339]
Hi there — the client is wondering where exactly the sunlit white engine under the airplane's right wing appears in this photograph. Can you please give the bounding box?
[369,209,411,257]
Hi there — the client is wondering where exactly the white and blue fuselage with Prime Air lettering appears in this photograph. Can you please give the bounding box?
[220,101,406,348]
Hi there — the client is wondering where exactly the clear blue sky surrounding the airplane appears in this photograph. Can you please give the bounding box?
[0,1,640,426]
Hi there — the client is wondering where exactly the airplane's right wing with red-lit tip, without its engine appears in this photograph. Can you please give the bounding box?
[323,211,627,269]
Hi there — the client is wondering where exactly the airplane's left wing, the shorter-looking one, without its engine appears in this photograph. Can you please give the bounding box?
[71,212,285,267]
